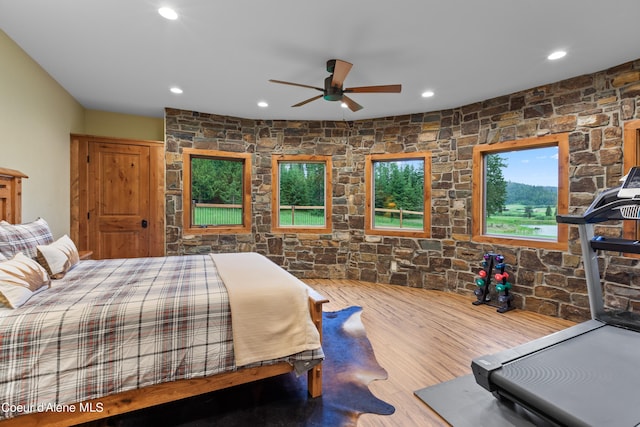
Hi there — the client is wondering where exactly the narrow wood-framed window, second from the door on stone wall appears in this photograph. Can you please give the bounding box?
[271,155,332,233]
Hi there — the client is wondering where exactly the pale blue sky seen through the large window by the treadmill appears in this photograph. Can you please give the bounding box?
[500,147,558,187]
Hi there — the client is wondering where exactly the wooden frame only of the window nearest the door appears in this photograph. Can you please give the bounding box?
[182,148,251,235]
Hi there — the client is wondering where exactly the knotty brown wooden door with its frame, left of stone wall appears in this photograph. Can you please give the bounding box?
[71,135,164,259]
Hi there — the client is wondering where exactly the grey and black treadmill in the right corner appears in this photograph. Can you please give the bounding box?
[471,167,640,427]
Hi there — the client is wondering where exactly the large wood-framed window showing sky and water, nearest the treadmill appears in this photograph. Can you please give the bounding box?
[472,134,569,249]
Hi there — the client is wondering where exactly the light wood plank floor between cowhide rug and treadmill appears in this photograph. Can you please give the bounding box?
[305,279,574,427]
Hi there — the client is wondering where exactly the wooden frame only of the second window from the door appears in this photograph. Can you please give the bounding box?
[271,154,333,234]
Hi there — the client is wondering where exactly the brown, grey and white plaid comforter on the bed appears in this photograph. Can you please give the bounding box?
[0,255,323,419]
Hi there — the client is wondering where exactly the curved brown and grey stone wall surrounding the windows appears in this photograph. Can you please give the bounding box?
[165,60,640,321]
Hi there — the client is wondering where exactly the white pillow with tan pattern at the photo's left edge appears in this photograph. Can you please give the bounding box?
[0,252,51,308]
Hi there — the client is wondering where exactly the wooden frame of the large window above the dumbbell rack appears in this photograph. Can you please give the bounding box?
[471,133,569,250]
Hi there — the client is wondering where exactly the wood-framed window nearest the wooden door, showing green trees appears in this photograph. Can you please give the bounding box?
[182,148,251,234]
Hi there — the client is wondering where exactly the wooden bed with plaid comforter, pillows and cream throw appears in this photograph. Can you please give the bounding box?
[0,219,327,426]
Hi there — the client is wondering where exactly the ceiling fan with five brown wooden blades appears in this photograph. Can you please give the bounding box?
[269,59,402,111]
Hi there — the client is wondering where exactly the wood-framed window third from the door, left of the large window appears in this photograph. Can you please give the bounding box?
[365,153,431,237]
